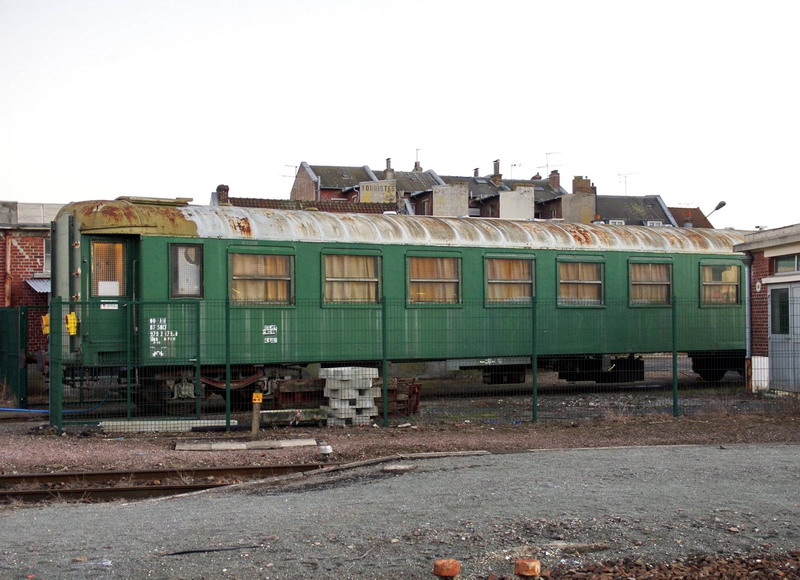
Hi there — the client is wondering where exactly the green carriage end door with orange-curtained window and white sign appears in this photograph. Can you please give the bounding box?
[83,238,131,364]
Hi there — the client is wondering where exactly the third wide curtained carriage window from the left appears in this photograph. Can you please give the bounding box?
[408,257,461,304]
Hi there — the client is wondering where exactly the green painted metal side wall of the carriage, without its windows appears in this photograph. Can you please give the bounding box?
[54,236,744,366]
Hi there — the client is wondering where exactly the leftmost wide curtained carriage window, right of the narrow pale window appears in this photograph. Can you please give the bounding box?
[231,253,293,304]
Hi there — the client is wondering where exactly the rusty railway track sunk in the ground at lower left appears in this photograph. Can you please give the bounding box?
[0,463,334,503]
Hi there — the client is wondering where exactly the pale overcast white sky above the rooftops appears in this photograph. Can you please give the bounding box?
[0,0,800,229]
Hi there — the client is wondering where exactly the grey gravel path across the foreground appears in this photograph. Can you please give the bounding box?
[0,444,800,579]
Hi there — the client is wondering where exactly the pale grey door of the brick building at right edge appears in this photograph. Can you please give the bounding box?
[769,283,800,392]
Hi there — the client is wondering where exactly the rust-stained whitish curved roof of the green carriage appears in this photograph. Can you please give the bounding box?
[62,198,744,254]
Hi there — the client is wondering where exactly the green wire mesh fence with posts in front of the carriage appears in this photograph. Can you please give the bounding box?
[50,300,796,430]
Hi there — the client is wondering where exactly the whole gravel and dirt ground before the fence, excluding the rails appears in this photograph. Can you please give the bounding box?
[0,393,800,579]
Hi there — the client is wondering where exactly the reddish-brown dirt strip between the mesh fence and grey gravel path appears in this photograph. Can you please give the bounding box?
[0,411,800,473]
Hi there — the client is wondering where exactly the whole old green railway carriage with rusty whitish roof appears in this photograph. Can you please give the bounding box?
[53,198,745,406]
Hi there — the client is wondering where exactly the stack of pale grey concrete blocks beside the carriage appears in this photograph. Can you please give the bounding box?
[319,367,381,427]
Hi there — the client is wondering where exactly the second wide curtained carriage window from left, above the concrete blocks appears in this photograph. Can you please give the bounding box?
[323,254,379,304]
